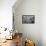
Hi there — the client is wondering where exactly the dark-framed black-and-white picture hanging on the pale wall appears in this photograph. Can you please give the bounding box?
[22,15,35,24]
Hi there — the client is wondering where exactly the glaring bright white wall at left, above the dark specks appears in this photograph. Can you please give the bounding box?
[0,0,16,29]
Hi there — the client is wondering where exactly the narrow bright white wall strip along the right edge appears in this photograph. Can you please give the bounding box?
[41,0,46,46]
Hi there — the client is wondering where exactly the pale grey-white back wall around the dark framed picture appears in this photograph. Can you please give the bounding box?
[13,0,41,46]
